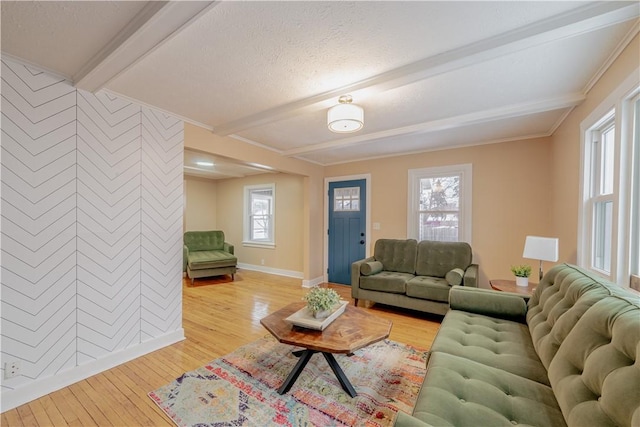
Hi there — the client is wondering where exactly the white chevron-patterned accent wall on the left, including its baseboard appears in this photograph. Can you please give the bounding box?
[0,58,184,411]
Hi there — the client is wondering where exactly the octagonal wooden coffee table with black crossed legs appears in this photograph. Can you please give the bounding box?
[260,302,391,397]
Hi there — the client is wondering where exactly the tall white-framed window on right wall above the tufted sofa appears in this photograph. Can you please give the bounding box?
[578,77,640,287]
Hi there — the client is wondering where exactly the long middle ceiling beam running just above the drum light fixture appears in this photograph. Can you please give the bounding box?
[213,2,639,136]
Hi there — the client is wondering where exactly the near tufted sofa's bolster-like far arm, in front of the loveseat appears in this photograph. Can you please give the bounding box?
[449,286,527,323]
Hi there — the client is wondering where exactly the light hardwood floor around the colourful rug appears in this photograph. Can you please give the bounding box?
[1,270,442,427]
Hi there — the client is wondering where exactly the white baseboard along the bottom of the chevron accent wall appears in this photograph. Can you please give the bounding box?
[0,328,185,412]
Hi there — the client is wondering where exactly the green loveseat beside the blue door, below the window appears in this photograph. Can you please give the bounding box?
[351,239,478,314]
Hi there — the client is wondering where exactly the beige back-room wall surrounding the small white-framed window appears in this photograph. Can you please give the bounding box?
[218,173,304,273]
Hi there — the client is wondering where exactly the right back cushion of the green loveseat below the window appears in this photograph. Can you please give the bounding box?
[415,240,472,277]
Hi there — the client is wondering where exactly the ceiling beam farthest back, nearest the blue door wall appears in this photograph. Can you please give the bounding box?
[282,93,586,156]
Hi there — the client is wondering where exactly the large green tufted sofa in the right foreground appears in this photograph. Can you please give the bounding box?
[395,264,640,427]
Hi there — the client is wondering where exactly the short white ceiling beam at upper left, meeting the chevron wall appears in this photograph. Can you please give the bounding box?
[73,1,217,92]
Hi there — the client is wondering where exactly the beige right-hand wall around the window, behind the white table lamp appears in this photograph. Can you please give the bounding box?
[549,35,640,270]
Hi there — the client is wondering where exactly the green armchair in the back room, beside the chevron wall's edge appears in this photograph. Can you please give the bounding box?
[183,230,238,284]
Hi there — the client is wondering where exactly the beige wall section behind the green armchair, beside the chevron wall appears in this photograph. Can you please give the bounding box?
[184,176,217,231]
